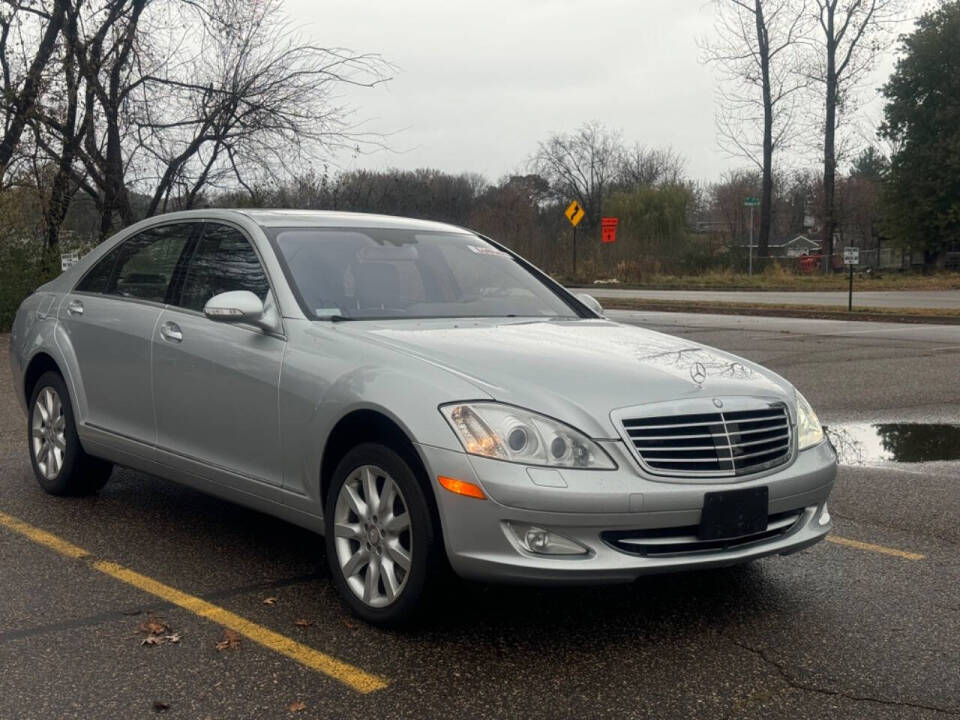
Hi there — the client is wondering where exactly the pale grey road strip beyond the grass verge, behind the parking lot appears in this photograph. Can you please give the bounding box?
[571,284,960,312]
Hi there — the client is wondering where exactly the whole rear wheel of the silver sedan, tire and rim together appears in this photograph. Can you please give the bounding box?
[27,371,113,495]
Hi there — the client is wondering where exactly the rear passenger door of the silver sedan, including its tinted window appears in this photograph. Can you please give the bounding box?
[59,222,199,445]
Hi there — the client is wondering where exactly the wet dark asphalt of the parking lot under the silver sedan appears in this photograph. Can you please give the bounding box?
[0,312,960,720]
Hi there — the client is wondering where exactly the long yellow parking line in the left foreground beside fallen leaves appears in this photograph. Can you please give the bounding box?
[0,512,387,693]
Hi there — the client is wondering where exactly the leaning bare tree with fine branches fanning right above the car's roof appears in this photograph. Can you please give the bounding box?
[136,0,389,214]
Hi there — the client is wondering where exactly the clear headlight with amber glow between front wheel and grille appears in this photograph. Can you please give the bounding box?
[440,402,617,470]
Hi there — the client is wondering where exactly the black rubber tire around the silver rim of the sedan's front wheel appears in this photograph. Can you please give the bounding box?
[324,443,445,627]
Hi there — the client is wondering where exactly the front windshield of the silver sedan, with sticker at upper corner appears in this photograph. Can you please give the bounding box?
[270,228,578,319]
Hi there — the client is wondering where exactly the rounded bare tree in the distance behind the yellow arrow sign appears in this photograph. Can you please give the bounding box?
[531,122,623,227]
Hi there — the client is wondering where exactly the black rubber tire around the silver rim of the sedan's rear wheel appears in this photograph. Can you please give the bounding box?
[27,370,113,496]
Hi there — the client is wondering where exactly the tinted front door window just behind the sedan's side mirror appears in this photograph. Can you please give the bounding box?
[179,223,270,311]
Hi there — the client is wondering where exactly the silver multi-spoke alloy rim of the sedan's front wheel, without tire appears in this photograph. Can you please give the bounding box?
[334,465,413,607]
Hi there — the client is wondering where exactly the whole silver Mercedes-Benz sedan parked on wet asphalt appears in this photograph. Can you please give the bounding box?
[11,210,836,624]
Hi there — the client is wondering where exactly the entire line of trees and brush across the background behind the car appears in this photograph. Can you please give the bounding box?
[0,0,960,326]
